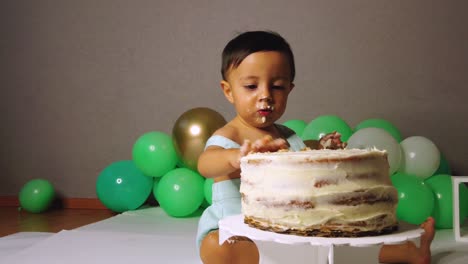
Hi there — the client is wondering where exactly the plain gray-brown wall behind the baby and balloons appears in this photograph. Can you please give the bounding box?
[0,0,468,197]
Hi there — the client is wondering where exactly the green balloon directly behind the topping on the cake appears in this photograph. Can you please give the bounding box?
[302,115,353,142]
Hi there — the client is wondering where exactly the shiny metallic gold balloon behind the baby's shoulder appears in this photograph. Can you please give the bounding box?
[172,107,226,171]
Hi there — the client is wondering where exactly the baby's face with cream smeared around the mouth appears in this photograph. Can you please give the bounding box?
[223,51,294,127]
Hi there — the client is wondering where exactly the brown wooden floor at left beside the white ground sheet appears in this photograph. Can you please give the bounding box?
[0,206,116,237]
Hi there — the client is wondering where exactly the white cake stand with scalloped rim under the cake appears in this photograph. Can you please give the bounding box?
[219,214,424,264]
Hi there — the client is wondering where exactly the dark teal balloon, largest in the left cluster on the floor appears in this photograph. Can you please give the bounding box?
[96,160,154,213]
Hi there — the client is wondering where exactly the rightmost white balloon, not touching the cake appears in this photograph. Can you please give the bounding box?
[399,136,440,179]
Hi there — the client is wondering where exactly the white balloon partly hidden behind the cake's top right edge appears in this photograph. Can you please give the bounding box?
[348,127,402,175]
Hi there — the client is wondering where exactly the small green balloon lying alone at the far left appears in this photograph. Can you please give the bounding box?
[19,179,55,213]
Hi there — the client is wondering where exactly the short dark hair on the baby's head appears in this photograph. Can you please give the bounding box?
[221,31,296,82]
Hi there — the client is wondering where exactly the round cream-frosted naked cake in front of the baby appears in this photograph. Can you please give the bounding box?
[240,149,398,237]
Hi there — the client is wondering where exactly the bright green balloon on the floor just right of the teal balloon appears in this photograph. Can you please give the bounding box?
[156,168,205,217]
